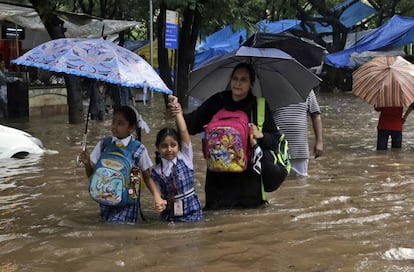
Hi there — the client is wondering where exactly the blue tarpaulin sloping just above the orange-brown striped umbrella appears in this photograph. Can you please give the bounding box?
[325,15,414,68]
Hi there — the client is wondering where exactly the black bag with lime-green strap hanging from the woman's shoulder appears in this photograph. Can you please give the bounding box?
[257,97,291,192]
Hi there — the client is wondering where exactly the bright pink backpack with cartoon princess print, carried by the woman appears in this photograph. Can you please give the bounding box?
[202,109,249,172]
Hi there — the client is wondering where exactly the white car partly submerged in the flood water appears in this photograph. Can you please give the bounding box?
[0,125,45,159]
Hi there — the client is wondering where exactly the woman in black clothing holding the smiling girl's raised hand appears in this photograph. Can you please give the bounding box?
[168,62,280,210]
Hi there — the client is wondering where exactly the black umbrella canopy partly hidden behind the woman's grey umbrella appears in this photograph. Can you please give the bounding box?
[243,32,327,68]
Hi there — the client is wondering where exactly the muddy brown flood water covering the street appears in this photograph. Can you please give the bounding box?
[0,93,414,272]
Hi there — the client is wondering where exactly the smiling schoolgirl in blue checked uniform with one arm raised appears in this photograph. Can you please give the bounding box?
[151,96,203,222]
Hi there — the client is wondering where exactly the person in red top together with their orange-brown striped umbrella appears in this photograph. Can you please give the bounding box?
[352,56,414,150]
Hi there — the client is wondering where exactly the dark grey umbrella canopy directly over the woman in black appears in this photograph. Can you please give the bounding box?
[188,46,320,109]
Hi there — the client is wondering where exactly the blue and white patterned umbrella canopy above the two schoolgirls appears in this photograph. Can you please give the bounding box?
[11,38,172,94]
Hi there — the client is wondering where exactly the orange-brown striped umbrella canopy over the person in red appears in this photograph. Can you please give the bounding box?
[352,56,414,107]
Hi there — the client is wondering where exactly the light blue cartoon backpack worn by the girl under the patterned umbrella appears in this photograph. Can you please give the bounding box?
[89,137,141,207]
